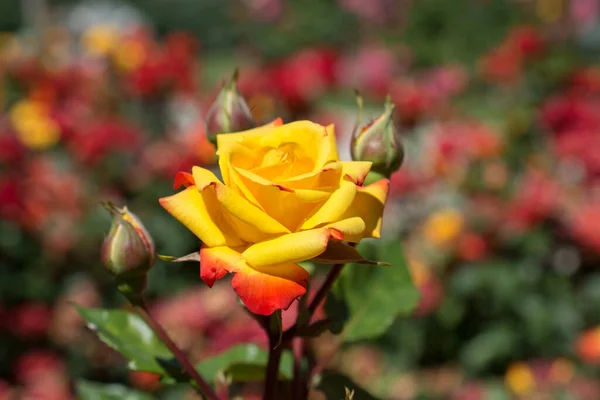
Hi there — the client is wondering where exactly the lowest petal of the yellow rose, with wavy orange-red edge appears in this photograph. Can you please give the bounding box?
[200,247,309,315]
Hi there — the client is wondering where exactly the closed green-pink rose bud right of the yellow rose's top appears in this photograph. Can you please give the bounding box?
[351,92,404,177]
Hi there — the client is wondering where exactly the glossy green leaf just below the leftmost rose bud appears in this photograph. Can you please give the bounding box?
[77,307,174,374]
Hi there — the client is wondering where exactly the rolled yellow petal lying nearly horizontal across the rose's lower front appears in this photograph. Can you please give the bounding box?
[242,228,332,268]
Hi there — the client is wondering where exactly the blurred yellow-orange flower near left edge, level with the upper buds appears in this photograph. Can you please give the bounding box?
[10,99,60,150]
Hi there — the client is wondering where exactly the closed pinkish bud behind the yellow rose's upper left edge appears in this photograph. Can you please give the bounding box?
[205,70,256,144]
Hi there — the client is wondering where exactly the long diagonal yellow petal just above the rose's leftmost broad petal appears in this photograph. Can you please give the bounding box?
[192,167,290,239]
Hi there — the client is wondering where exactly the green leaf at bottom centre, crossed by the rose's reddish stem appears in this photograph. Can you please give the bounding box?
[196,344,294,382]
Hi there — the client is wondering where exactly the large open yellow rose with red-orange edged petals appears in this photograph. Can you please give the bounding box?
[160,120,389,315]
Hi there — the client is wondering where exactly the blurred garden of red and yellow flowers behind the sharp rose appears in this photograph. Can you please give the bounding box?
[0,0,600,400]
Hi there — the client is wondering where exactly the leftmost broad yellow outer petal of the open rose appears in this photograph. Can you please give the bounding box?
[159,186,242,246]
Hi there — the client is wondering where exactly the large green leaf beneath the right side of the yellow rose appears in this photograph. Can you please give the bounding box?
[326,242,419,342]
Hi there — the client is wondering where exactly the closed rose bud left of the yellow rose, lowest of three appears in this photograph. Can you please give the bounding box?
[101,201,155,304]
